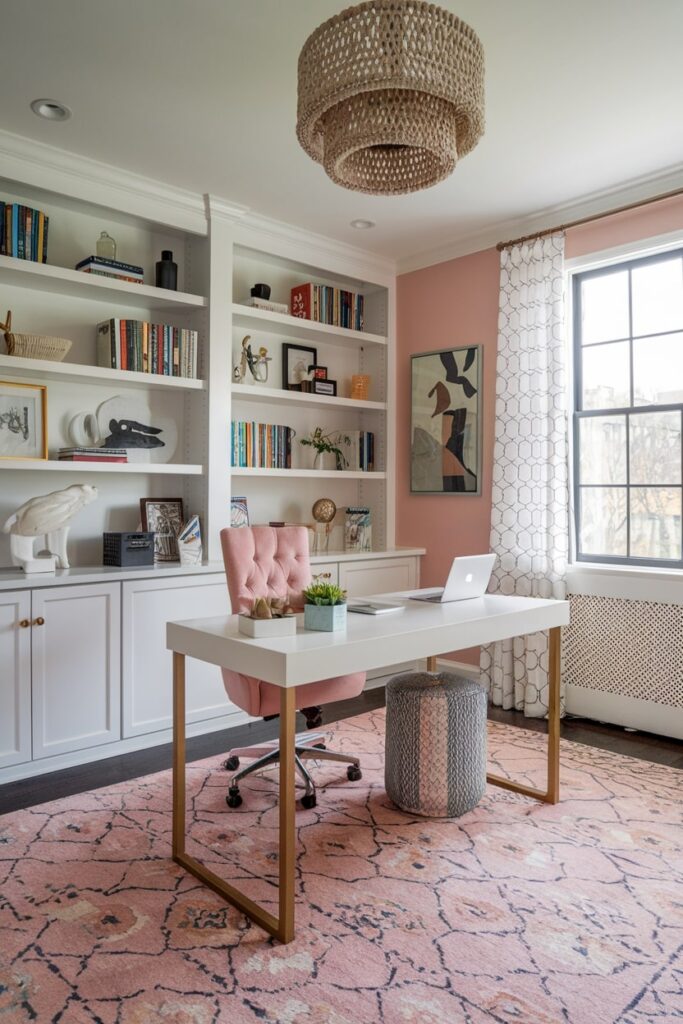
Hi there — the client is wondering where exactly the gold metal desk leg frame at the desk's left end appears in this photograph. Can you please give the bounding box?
[173,651,295,942]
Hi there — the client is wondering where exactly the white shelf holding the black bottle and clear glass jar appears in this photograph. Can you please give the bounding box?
[0,256,207,310]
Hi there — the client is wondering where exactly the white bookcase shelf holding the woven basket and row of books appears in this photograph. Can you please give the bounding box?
[0,355,206,391]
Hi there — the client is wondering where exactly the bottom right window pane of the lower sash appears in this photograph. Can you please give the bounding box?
[631,487,681,560]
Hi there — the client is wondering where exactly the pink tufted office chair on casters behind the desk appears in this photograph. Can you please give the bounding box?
[220,526,366,808]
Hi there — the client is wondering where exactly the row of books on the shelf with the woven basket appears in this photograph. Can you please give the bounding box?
[97,317,197,377]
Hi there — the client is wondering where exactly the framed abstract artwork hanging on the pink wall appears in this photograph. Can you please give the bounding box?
[411,345,482,495]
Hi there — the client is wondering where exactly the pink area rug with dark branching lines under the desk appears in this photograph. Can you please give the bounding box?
[0,712,683,1024]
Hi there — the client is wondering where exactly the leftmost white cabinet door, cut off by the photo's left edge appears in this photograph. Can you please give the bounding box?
[0,590,31,768]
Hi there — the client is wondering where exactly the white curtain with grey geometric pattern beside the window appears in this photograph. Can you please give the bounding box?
[481,234,569,718]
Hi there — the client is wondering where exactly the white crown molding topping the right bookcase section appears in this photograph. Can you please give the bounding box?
[234,210,396,285]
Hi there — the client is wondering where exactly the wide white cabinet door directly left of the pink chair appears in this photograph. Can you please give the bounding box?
[123,572,237,736]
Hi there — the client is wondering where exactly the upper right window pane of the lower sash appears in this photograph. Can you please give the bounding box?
[629,413,681,483]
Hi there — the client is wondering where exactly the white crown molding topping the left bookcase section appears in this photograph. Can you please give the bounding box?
[0,131,208,234]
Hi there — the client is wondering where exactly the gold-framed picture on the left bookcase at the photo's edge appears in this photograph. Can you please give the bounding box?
[0,381,47,459]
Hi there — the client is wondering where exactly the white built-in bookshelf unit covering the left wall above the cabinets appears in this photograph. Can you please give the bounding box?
[0,135,394,567]
